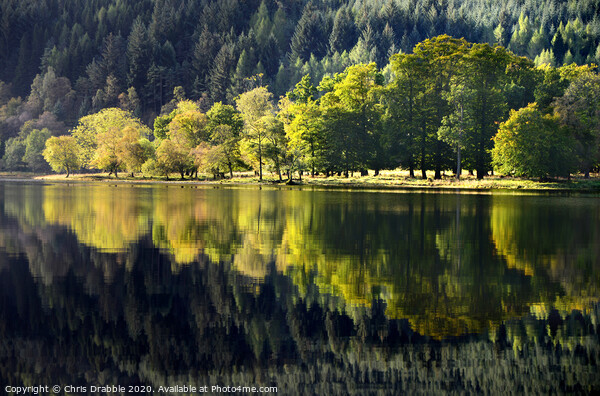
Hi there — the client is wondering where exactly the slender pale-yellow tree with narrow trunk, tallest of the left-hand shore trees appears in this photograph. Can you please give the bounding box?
[236,87,273,181]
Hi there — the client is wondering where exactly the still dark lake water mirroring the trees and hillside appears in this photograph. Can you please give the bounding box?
[0,182,600,395]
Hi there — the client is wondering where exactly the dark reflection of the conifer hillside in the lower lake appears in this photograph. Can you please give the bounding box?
[0,240,600,395]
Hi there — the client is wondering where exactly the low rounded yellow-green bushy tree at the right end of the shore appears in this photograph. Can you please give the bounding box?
[492,103,575,179]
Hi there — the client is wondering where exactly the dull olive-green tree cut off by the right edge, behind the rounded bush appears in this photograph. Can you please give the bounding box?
[554,72,600,178]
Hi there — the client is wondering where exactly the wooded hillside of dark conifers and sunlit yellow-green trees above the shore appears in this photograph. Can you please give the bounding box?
[0,0,600,179]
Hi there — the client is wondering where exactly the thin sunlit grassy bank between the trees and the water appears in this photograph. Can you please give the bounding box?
[0,171,600,192]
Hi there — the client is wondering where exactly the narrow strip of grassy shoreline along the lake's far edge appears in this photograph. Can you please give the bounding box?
[0,173,600,194]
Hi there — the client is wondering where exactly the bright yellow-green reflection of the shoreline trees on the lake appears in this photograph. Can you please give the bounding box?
[0,181,600,339]
